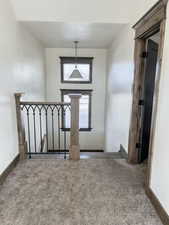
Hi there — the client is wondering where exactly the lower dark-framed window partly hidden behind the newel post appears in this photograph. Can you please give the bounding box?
[61,89,92,131]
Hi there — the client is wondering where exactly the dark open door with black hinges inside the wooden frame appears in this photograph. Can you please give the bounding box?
[139,40,158,162]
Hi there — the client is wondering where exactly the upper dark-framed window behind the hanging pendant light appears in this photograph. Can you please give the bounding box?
[60,57,93,84]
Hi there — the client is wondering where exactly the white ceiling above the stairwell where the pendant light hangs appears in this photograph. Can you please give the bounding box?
[21,22,125,48]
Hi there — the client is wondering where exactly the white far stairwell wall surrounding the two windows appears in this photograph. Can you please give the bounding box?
[46,48,106,150]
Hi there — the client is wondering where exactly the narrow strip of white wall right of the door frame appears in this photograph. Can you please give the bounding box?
[151,3,169,215]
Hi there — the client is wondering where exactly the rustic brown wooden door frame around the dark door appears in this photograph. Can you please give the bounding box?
[128,0,168,187]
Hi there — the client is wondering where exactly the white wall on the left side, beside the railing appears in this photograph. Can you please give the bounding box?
[0,0,45,174]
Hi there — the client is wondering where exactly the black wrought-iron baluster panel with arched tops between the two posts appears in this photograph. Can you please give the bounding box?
[20,102,70,159]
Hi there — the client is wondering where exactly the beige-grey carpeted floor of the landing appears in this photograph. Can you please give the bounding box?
[0,159,162,225]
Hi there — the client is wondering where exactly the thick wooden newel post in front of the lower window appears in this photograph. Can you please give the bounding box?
[69,94,81,160]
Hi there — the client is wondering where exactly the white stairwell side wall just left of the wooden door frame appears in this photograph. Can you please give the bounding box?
[105,25,134,152]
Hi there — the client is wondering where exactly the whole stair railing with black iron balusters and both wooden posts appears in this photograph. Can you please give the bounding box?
[15,93,81,160]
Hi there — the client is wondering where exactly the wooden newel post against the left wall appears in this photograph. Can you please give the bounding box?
[14,93,27,160]
